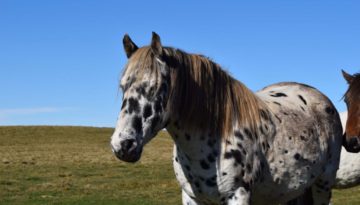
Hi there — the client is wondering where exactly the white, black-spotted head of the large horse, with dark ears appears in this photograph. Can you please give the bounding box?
[111,33,170,162]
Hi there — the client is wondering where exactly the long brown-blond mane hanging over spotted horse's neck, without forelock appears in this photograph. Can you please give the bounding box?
[169,54,261,138]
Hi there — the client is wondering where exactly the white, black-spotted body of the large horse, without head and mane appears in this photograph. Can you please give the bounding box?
[168,83,341,204]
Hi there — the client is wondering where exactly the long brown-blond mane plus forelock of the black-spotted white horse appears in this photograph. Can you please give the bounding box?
[127,47,263,137]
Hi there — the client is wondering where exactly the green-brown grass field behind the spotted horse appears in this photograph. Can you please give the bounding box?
[0,127,360,205]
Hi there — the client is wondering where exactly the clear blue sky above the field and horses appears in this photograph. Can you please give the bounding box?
[0,0,360,127]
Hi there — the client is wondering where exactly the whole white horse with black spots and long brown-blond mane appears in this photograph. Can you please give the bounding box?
[110,32,342,205]
